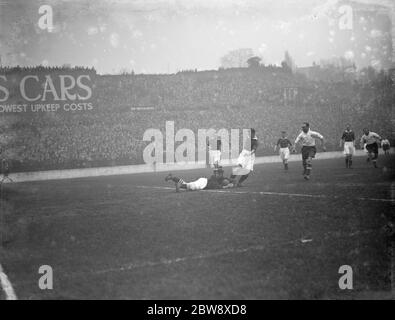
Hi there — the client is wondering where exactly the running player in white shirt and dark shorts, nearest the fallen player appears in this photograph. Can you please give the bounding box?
[293,122,326,180]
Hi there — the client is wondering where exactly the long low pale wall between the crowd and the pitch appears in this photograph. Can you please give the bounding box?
[4,148,394,183]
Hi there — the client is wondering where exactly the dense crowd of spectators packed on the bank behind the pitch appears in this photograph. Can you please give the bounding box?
[0,68,395,171]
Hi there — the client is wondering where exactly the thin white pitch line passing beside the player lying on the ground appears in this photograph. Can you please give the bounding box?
[136,186,395,203]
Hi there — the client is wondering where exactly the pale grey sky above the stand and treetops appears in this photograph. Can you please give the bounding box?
[0,0,395,73]
